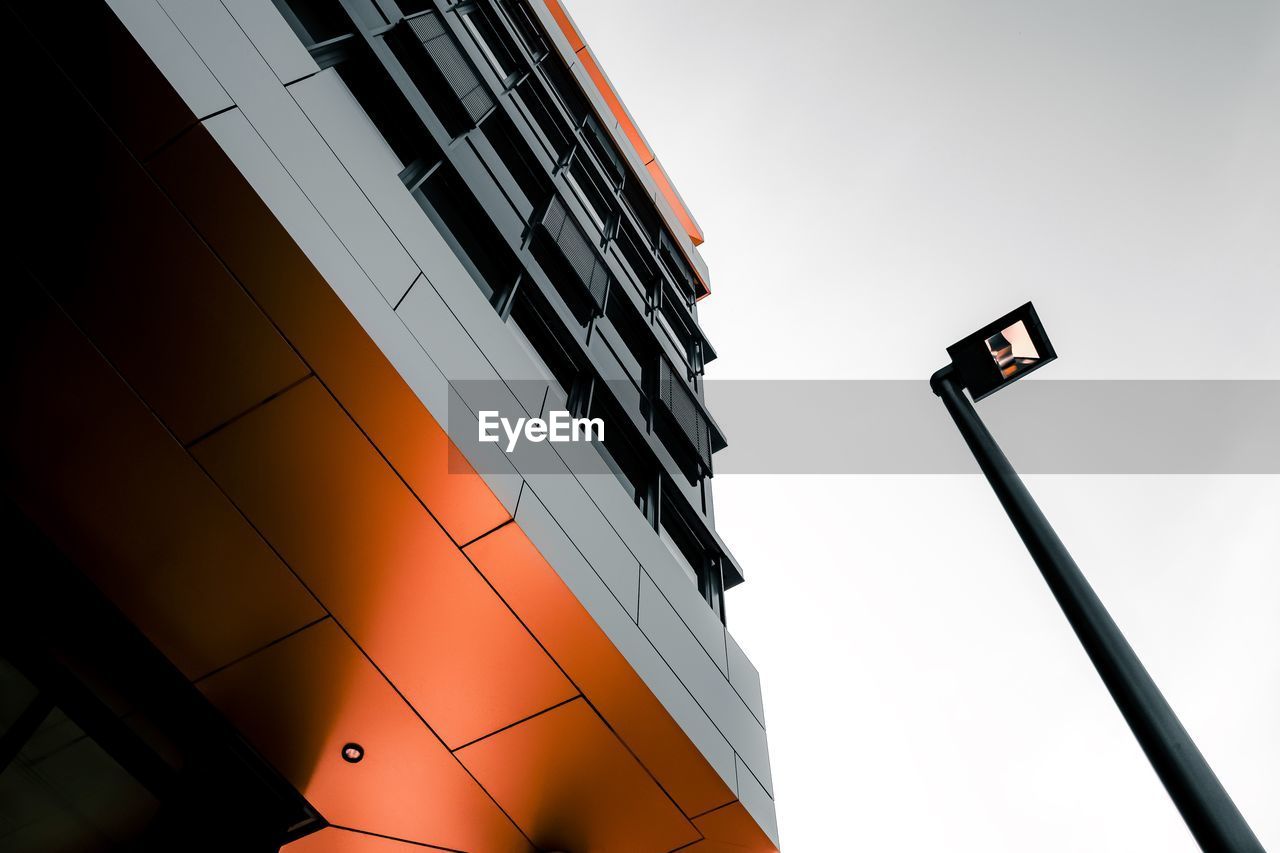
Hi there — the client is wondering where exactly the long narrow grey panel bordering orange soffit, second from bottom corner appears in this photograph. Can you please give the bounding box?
[516,488,737,790]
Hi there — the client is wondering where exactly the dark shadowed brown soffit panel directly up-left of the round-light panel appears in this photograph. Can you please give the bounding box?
[0,279,324,678]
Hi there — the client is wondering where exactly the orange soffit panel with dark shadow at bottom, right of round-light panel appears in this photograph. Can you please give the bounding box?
[456,699,699,853]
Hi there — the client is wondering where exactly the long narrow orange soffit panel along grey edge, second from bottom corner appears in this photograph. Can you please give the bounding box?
[466,524,733,815]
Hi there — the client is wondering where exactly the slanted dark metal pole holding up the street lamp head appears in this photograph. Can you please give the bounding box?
[929,365,1265,853]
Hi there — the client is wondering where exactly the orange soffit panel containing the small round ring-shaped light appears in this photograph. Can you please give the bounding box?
[197,620,531,853]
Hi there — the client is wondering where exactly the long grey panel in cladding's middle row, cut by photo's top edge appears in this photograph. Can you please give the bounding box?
[163,0,419,304]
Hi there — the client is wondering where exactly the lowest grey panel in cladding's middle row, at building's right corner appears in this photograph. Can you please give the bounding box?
[640,573,773,792]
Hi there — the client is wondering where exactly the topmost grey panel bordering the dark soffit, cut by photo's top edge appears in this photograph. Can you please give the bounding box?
[108,0,232,118]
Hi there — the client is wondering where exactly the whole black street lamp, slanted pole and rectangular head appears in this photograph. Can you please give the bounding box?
[929,302,1263,853]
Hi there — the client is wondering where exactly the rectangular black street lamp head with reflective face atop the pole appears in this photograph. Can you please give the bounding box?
[947,302,1057,402]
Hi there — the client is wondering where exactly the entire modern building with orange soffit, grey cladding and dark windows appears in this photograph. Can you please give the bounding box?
[0,0,778,853]
